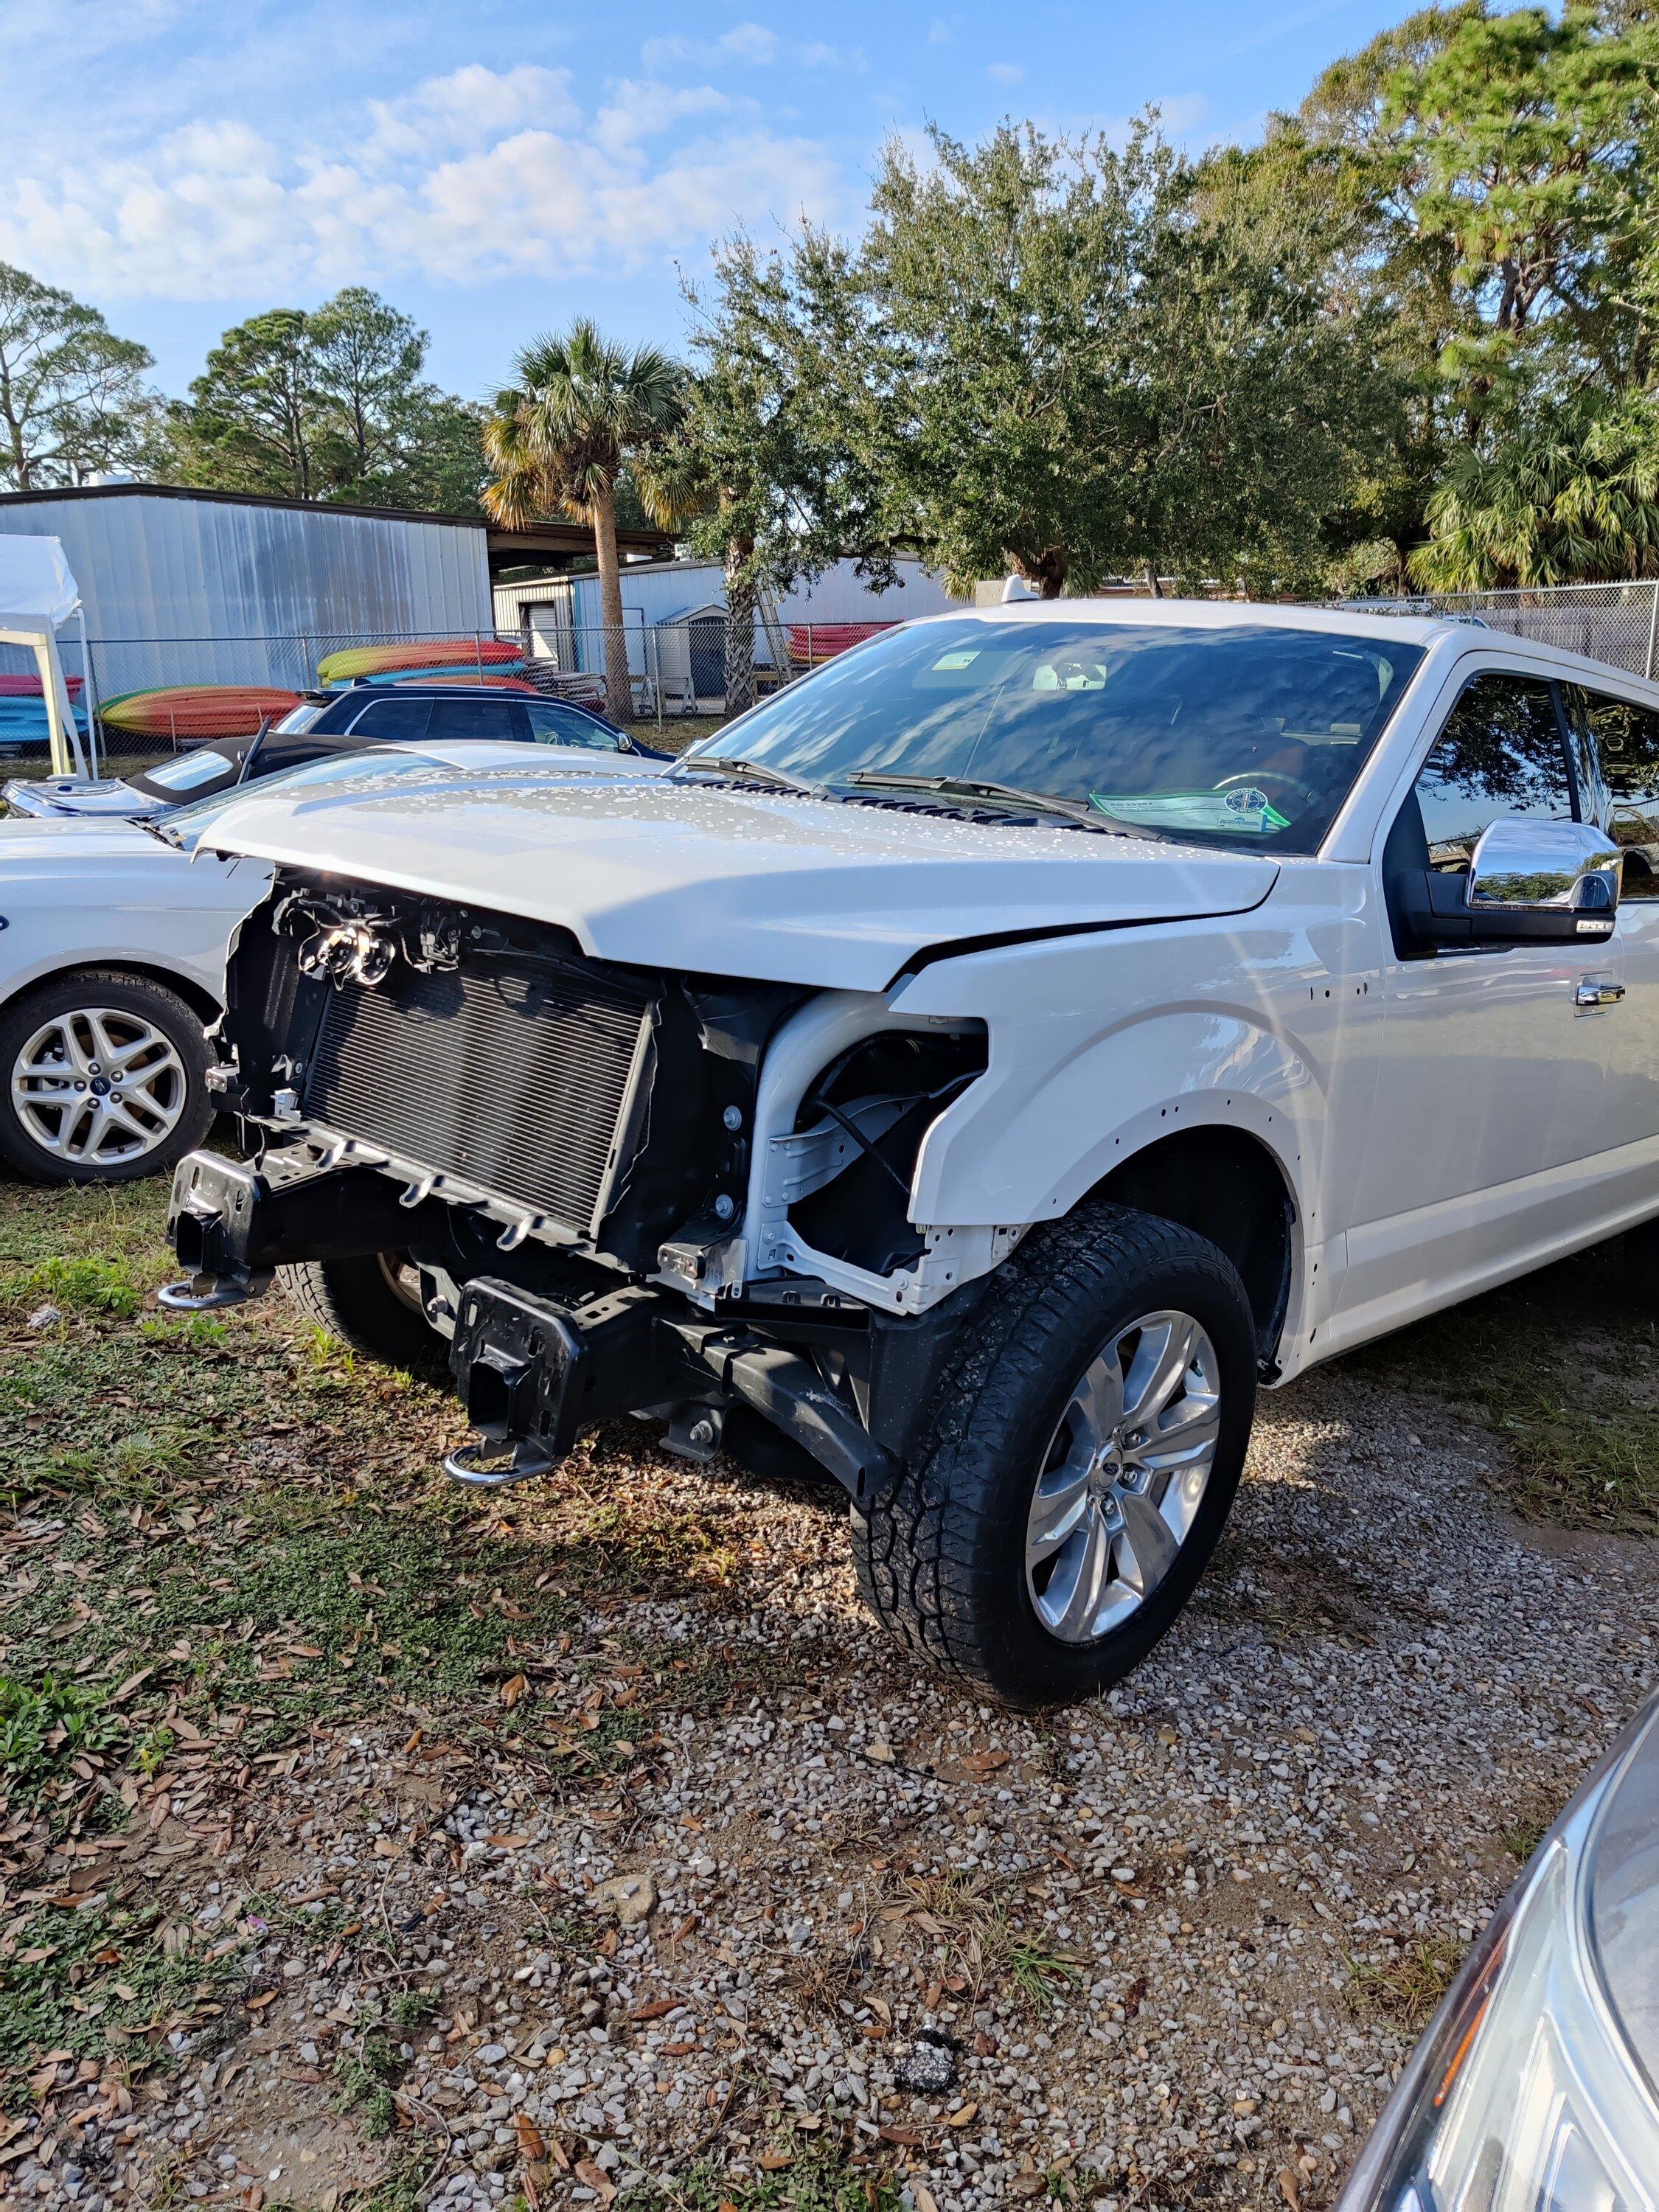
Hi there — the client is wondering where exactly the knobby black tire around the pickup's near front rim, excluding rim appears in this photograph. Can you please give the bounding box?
[852,1206,1256,1708]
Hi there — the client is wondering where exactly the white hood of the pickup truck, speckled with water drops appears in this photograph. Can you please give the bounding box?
[201,768,1279,991]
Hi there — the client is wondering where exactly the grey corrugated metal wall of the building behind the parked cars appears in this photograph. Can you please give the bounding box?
[0,491,495,690]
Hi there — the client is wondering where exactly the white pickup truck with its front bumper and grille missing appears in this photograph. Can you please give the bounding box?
[166,602,1659,1703]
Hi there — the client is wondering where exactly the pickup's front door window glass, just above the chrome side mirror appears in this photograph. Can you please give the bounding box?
[1416,675,1573,874]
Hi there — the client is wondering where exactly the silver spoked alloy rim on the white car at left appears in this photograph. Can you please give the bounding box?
[11,1006,190,1168]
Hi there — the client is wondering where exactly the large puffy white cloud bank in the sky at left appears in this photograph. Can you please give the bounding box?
[0,64,845,301]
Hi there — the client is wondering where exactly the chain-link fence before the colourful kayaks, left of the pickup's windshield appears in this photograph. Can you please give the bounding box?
[0,608,911,768]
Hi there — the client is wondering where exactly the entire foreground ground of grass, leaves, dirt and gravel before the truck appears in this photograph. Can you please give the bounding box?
[0,1192,1659,2212]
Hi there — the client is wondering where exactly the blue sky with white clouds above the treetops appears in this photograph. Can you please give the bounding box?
[0,0,1433,398]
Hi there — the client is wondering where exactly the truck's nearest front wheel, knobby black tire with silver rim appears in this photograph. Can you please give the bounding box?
[854,1206,1256,1705]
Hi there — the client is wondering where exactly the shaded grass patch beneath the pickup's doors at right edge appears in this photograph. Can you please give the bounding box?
[1345,1245,1659,1535]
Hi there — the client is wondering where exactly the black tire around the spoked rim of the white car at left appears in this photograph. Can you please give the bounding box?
[0,969,215,1183]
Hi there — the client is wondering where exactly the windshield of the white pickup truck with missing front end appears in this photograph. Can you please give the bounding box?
[688,617,1422,852]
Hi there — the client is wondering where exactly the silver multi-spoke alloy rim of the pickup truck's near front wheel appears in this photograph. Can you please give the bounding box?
[1026,1312,1221,1644]
